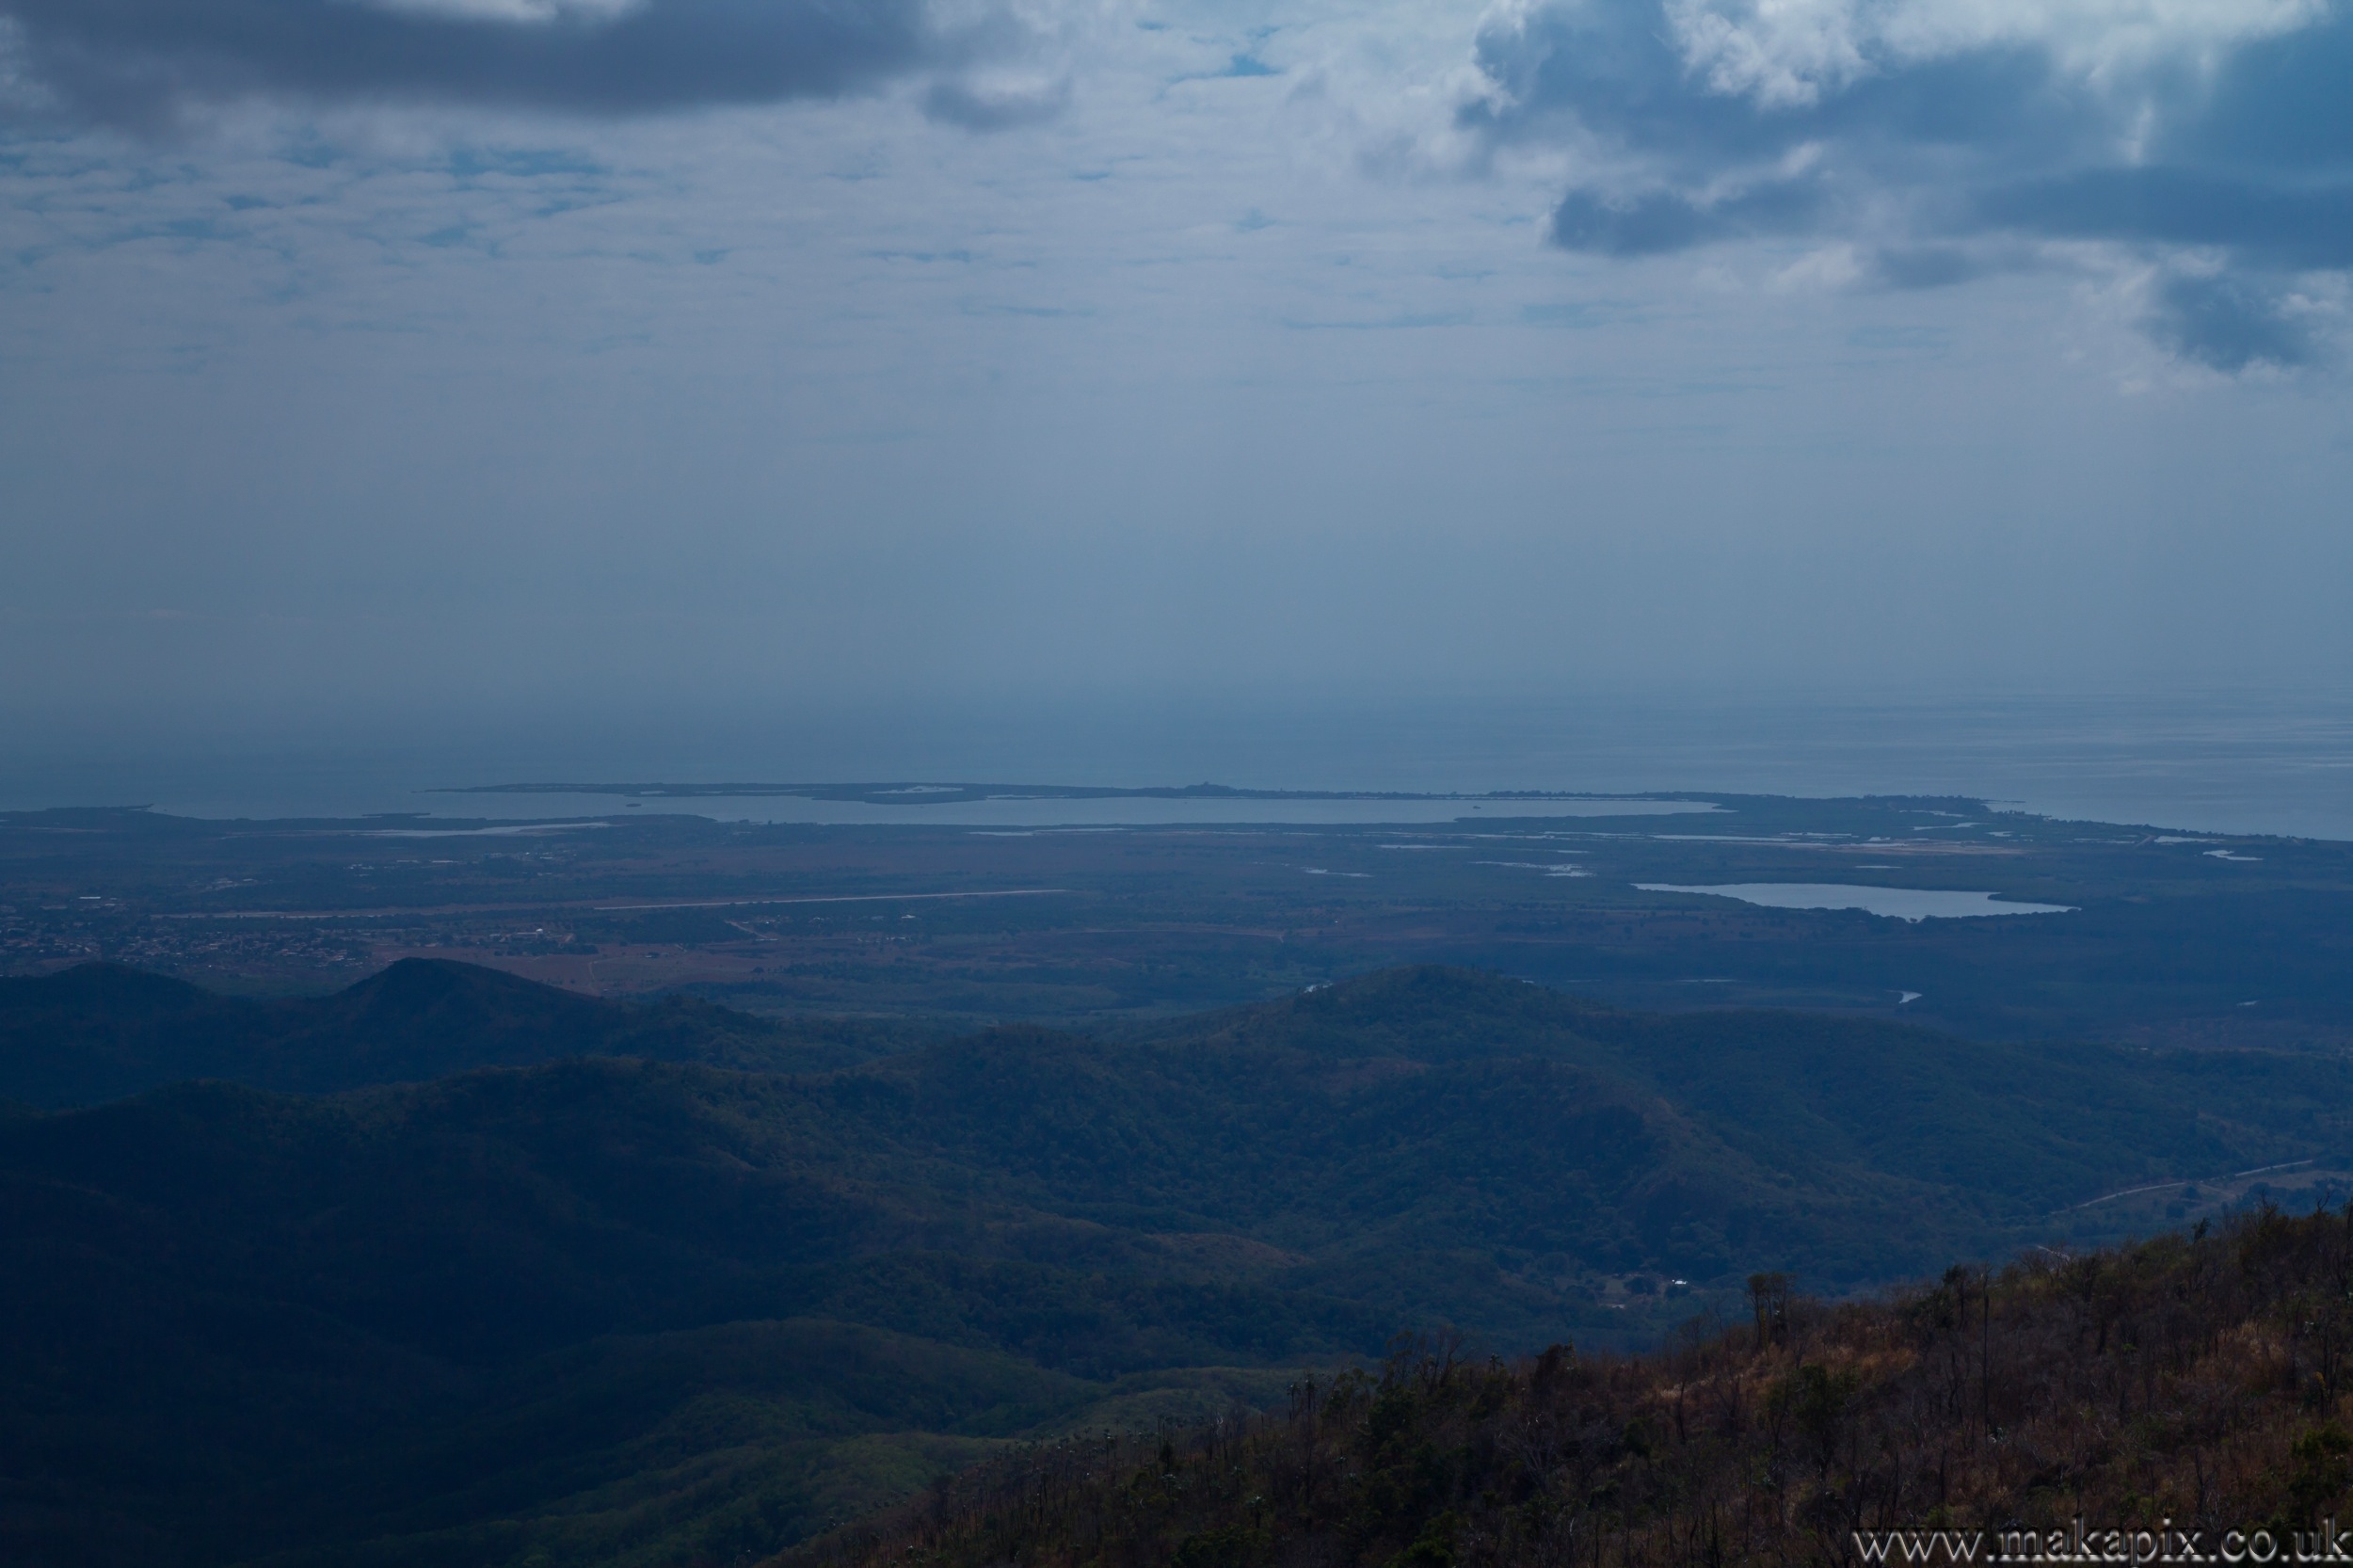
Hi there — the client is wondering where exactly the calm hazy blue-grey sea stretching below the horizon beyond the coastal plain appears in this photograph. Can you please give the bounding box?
[0,695,2353,840]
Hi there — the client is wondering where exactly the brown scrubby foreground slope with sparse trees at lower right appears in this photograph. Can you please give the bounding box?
[784,1210,2353,1568]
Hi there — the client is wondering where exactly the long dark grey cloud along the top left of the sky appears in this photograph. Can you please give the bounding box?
[0,0,949,125]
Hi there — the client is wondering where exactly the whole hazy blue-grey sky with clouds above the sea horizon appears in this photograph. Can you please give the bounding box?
[0,0,2353,751]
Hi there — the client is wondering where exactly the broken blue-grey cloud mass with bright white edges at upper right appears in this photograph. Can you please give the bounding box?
[1466,0,2353,370]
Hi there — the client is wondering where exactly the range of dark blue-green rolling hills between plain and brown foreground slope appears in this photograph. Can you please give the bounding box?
[0,966,2353,1565]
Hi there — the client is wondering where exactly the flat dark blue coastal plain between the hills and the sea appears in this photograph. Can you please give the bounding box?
[0,784,2353,1048]
